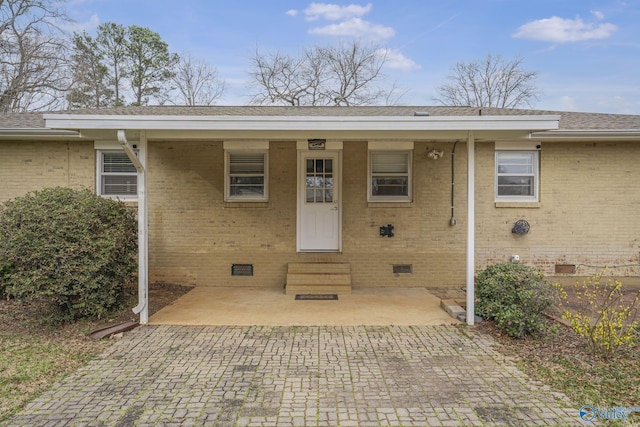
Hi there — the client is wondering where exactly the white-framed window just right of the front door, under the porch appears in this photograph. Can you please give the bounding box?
[369,151,411,202]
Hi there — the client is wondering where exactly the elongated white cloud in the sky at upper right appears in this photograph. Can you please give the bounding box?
[513,16,618,43]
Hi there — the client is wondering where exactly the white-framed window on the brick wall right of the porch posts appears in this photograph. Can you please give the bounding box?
[495,150,539,202]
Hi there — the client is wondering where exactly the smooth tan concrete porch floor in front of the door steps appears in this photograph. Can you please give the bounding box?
[149,287,459,326]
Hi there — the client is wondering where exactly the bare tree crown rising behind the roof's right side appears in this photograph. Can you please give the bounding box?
[434,54,540,108]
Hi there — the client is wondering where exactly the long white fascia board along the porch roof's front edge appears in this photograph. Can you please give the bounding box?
[44,114,560,131]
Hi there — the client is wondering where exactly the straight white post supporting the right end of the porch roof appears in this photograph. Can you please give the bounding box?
[467,131,476,325]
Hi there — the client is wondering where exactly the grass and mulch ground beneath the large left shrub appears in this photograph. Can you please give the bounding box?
[0,283,191,424]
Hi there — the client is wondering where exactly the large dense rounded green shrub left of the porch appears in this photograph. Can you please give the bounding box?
[0,187,137,320]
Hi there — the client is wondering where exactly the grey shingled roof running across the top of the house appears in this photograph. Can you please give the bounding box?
[0,106,640,130]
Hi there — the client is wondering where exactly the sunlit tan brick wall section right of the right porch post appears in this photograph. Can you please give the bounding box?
[476,142,640,276]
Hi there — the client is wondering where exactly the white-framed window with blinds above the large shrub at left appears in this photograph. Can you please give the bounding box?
[97,150,138,199]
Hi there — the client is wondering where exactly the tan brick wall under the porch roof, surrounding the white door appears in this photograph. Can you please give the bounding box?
[149,141,466,287]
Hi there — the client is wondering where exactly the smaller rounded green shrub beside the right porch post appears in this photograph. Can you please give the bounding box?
[475,262,554,338]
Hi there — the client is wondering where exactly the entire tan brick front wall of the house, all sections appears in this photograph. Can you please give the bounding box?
[5,137,640,287]
